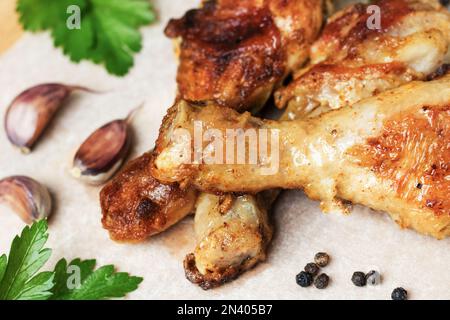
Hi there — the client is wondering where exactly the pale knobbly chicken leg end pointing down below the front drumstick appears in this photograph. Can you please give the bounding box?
[184,190,278,290]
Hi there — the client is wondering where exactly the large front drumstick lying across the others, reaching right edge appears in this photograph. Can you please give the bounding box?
[152,75,450,239]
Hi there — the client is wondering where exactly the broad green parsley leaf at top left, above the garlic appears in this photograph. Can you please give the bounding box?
[17,0,156,76]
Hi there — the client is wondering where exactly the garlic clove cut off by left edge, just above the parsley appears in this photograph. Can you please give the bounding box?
[0,176,52,224]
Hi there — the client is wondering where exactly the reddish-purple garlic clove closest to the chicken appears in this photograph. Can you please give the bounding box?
[71,119,131,185]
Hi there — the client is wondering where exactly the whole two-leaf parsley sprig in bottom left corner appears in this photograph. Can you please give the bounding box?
[0,220,143,300]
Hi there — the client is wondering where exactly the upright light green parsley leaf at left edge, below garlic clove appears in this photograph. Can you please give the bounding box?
[0,220,53,300]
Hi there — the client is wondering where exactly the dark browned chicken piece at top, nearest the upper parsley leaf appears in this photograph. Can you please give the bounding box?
[165,0,324,111]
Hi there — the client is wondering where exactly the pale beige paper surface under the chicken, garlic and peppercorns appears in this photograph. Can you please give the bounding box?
[0,0,450,299]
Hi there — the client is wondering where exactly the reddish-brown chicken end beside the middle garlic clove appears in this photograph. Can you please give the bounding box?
[100,153,197,242]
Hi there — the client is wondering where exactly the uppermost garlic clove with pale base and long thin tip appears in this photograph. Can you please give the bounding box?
[5,83,92,153]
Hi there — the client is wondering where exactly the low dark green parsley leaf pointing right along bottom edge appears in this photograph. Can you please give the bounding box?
[52,259,143,300]
